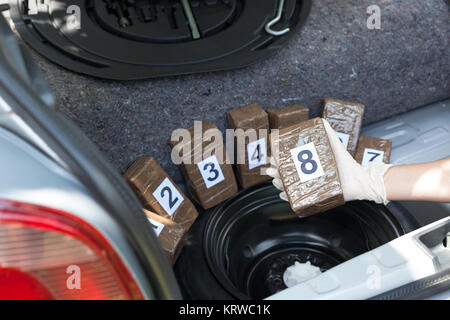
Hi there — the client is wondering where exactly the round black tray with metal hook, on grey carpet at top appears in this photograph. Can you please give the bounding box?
[9,0,312,80]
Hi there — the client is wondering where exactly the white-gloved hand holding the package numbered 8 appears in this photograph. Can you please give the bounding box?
[266,119,392,204]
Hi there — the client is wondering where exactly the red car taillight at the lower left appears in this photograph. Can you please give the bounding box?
[0,200,143,300]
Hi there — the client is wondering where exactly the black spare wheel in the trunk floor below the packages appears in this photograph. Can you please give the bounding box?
[175,184,414,299]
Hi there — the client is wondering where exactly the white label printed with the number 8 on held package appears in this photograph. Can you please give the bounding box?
[291,142,324,183]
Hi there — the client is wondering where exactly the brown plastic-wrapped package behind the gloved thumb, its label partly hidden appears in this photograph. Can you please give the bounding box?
[322,98,365,156]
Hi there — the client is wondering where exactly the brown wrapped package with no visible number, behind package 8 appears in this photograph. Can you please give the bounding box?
[267,104,309,130]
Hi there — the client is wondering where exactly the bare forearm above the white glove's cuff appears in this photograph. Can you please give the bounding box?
[384,159,450,202]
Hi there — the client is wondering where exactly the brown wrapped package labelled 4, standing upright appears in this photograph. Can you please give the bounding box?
[227,104,270,188]
